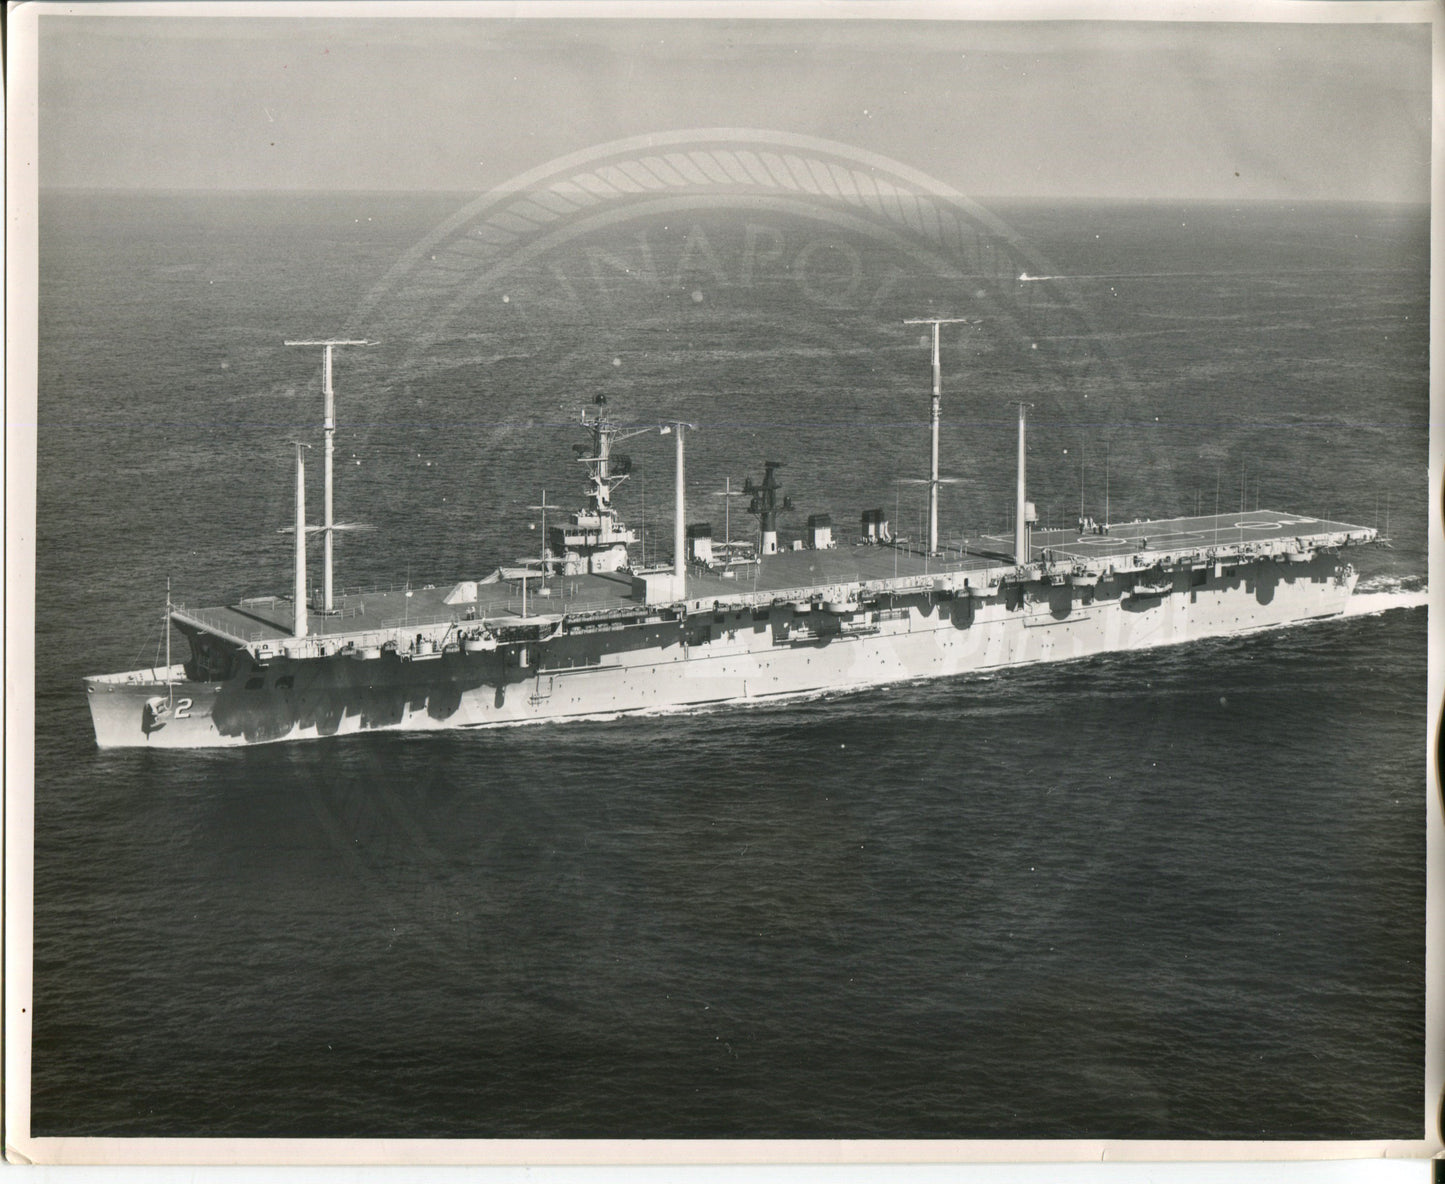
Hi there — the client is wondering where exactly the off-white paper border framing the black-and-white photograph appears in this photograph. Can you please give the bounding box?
[3,0,1445,1180]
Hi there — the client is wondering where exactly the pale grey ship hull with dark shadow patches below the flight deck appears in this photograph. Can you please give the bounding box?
[87,554,1355,749]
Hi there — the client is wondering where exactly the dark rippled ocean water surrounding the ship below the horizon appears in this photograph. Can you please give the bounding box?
[32,192,1428,1139]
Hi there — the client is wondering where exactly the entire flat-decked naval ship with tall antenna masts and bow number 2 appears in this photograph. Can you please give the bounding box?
[84,326,1379,749]
